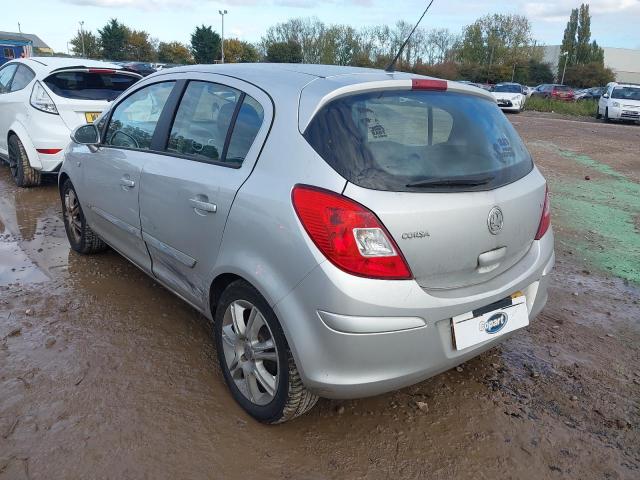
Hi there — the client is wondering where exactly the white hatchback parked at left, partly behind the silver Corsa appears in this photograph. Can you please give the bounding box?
[0,57,142,187]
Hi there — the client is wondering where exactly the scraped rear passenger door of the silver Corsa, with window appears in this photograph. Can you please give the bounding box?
[140,75,273,308]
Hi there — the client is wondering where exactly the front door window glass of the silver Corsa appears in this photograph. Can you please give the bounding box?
[105,82,175,150]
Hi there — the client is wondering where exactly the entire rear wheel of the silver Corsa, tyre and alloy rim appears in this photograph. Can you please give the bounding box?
[214,280,318,423]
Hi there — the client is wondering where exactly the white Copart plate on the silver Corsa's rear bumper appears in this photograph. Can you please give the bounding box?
[451,293,529,350]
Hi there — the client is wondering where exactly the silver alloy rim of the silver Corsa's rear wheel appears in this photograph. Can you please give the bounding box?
[222,300,281,405]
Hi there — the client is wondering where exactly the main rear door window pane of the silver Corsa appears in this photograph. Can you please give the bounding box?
[167,81,242,162]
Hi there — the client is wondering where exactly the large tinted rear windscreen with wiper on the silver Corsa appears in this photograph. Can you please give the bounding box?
[304,91,533,192]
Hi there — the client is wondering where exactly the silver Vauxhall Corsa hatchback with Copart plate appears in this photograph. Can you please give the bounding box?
[59,64,554,423]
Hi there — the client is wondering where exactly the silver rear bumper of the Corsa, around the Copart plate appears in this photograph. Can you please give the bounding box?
[275,230,555,398]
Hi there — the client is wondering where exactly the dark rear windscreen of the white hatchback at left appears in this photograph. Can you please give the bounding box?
[44,72,138,101]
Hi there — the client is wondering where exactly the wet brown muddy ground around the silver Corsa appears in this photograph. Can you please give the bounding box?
[0,114,640,479]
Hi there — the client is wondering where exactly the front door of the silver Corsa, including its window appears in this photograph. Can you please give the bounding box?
[83,81,175,271]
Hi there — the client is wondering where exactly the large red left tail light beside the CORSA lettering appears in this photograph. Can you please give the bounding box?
[291,185,412,280]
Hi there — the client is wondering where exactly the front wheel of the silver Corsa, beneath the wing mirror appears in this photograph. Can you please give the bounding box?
[60,178,107,254]
